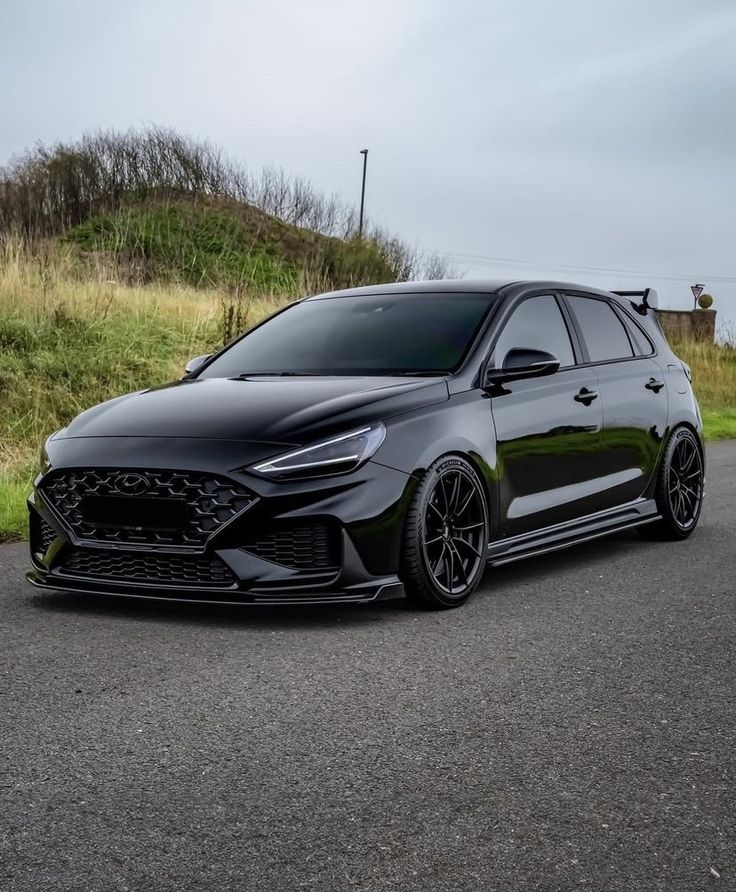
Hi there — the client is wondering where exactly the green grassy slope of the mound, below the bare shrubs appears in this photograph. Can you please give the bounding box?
[63,196,395,293]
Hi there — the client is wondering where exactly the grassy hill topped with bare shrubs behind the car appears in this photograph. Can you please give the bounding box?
[0,128,434,291]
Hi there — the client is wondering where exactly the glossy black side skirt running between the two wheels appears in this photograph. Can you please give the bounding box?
[488,499,660,567]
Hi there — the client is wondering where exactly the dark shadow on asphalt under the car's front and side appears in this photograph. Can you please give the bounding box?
[32,532,657,631]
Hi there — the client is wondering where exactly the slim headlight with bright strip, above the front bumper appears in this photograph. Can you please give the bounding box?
[251,423,386,479]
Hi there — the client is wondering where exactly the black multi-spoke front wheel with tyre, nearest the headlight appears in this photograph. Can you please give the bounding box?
[400,455,488,610]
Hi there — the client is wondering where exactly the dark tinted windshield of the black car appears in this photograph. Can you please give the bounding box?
[198,292,496,378]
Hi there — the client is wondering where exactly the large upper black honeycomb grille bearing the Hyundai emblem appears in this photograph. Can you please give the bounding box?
[40,468,257,548]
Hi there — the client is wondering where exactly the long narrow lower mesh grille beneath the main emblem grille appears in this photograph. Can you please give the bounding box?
[55,548,234,588]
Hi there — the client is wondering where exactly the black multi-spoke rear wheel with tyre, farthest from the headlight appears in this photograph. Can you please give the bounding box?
[638,427,705,541]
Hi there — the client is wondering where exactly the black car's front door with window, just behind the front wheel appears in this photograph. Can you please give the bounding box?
[490,294,603,536]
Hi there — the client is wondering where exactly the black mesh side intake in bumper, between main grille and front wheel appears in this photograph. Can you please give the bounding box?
[242,524,339,571]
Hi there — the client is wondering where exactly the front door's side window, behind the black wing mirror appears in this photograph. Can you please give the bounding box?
[493,294,575,368]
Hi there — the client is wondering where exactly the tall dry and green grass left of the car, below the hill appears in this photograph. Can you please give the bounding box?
[0,240,294,539]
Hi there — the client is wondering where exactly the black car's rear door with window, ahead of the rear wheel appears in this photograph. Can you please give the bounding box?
[565,293,668,507]
